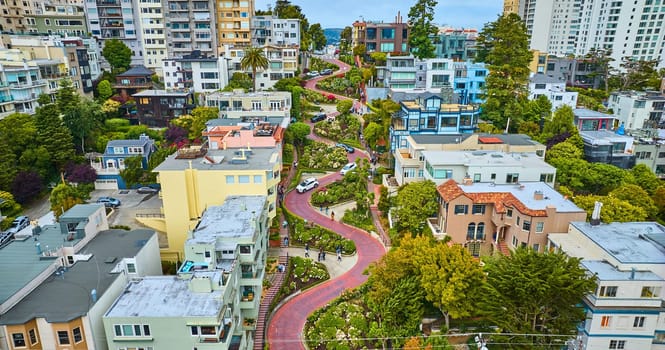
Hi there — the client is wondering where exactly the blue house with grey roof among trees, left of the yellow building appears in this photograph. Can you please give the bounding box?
[92,134,156,189]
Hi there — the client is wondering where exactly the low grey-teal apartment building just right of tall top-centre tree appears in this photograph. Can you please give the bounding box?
[434,27,478,62]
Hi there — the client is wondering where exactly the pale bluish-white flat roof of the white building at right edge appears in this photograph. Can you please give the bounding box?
[563,222,665,264]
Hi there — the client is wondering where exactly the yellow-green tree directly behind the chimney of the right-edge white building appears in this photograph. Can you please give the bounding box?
[573,195,647,223]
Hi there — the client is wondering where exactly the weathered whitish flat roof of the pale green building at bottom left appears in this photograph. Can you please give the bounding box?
[104,272,223,317]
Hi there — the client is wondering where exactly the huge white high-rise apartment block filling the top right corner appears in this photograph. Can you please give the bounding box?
[508,0,665,69]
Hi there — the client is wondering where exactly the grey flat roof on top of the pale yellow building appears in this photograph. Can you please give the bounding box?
[154,147,280,172]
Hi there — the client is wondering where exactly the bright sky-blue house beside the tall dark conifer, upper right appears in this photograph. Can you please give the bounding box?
[453,62,489,104]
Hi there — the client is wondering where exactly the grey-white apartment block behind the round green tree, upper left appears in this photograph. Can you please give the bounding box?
[84,0,143,69]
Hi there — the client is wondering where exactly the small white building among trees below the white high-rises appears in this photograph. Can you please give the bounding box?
[529,73,578,111]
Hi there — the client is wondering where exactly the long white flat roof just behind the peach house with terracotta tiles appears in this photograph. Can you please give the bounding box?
[422,151,556,173]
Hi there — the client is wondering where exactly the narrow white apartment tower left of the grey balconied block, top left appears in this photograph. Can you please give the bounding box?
[136,0,167,76]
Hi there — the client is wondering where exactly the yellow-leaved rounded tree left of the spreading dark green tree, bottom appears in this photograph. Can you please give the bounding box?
[418,242,484,329]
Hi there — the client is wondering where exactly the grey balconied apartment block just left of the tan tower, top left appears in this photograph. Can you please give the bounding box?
[164,0,215,58]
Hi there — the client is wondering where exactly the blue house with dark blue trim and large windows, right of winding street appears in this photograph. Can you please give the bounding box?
[390,92,480,151]
